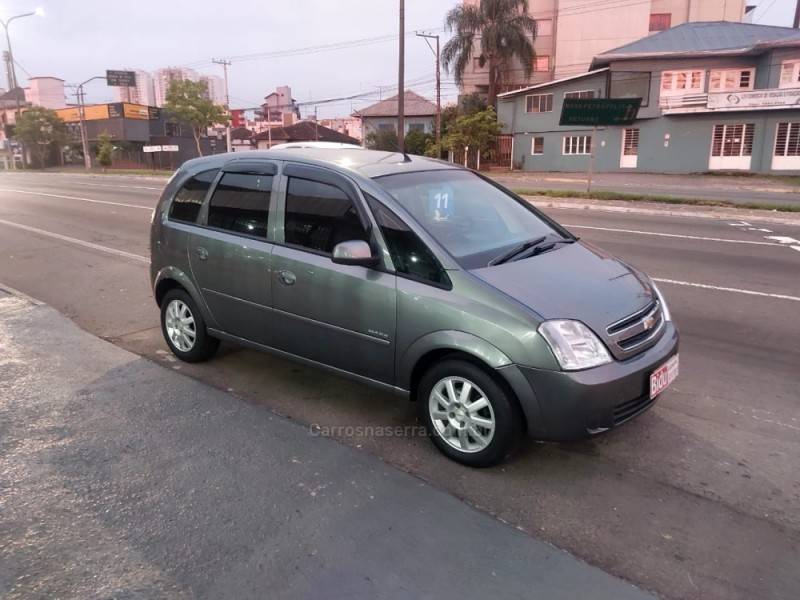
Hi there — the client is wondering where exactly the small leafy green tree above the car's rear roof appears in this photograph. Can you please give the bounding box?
[164,79,228,156]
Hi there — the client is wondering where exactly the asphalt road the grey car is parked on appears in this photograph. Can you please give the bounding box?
[0,174,800,600]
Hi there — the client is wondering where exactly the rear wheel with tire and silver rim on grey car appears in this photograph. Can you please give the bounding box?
[161,288,219,362]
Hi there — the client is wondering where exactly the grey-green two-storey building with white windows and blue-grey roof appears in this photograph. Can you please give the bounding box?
[498,21,800,175]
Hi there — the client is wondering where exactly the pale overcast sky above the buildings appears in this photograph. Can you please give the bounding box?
[0,0,795,117]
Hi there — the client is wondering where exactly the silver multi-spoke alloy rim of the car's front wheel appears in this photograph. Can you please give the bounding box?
[428,377,495,454]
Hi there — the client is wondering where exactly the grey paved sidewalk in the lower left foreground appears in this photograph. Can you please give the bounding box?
[0,291,651,600]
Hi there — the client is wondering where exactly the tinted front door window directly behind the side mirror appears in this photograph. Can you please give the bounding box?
[285,177,369,254]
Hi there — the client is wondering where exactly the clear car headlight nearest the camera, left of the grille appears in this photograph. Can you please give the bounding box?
[539,319,611,371]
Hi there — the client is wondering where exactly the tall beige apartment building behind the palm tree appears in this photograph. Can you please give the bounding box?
[460,0,746,94]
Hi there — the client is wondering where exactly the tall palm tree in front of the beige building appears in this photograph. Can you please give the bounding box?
[442,0,536,106]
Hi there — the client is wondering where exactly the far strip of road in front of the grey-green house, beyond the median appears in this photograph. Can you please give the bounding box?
[492,171,800,206]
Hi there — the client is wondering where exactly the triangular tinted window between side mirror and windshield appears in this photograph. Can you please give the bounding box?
[366,196,450,285]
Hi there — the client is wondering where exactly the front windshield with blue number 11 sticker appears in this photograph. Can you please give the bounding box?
[375,169,568,269]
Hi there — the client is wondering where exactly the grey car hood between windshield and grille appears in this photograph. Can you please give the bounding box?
[472,242,655,336]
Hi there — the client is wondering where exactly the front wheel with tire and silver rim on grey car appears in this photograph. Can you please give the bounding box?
[417,359,523,467]
